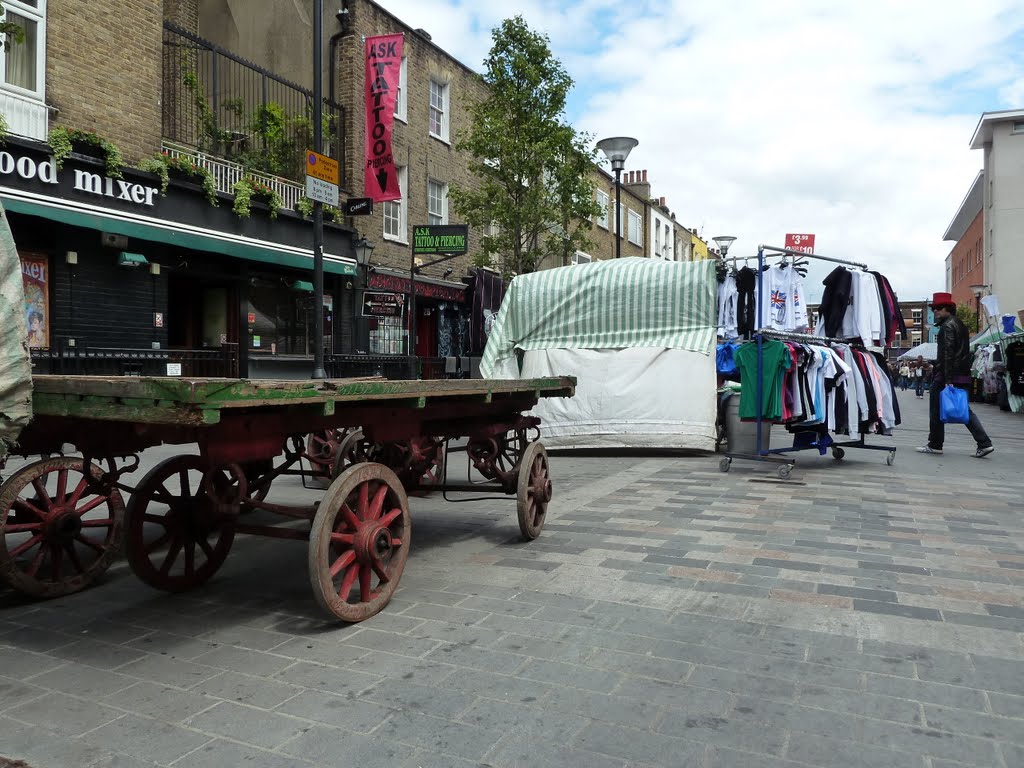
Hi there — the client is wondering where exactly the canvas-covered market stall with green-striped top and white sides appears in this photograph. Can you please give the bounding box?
[480,258,717,451]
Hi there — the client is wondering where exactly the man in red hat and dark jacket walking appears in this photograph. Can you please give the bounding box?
[918,293,995,459]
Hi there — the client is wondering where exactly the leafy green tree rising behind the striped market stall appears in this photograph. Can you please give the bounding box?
[449,16,600,274]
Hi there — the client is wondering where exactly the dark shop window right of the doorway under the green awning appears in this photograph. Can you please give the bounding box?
[248,276,333,355]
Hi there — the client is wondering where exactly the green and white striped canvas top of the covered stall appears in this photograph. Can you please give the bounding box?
[480,258,717,377]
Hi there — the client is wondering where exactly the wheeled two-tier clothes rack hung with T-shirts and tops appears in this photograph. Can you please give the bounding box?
[716,246,906,478]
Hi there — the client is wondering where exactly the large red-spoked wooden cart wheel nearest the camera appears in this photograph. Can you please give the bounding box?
[309,462,412,622]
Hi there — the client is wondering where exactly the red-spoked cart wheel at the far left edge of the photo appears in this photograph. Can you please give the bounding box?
[0,457,125,597]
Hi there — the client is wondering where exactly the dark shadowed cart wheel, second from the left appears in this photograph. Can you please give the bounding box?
[127,456,235,592]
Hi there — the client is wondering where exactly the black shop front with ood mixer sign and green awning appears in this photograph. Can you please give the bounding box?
[0,137,355,378]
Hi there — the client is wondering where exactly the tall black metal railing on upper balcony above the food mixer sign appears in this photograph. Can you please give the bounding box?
[163,22,346,186]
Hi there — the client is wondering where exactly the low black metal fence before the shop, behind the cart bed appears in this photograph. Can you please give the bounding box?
[32,344,239,378]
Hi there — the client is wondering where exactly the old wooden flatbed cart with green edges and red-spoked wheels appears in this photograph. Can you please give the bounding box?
[0,376,575,622]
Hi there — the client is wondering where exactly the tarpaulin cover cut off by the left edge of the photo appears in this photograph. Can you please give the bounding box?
[0,201,32,459]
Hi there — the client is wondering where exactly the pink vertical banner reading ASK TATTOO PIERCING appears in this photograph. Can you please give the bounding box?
[362,34,402,203]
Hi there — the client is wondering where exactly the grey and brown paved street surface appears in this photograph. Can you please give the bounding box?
[0,393,1024,768]
